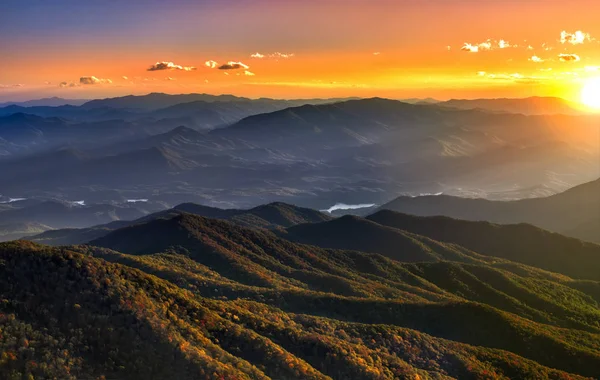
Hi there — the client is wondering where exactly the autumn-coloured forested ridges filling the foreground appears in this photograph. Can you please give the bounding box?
[0,209,600,379]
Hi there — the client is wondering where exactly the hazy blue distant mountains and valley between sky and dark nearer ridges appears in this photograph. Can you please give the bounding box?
[0,94,600,218]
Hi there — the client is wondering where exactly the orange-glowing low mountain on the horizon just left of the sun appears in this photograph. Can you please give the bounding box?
[438,97,582,115]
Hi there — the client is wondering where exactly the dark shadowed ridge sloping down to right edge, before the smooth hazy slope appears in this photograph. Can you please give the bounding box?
[367,210,600,280]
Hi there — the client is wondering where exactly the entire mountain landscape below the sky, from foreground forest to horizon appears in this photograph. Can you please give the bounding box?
[0,93,600,380]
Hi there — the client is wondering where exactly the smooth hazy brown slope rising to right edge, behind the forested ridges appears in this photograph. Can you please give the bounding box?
[380,179,600,242]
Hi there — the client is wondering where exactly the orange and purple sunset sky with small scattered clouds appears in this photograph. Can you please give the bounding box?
[0,0,600,101]
